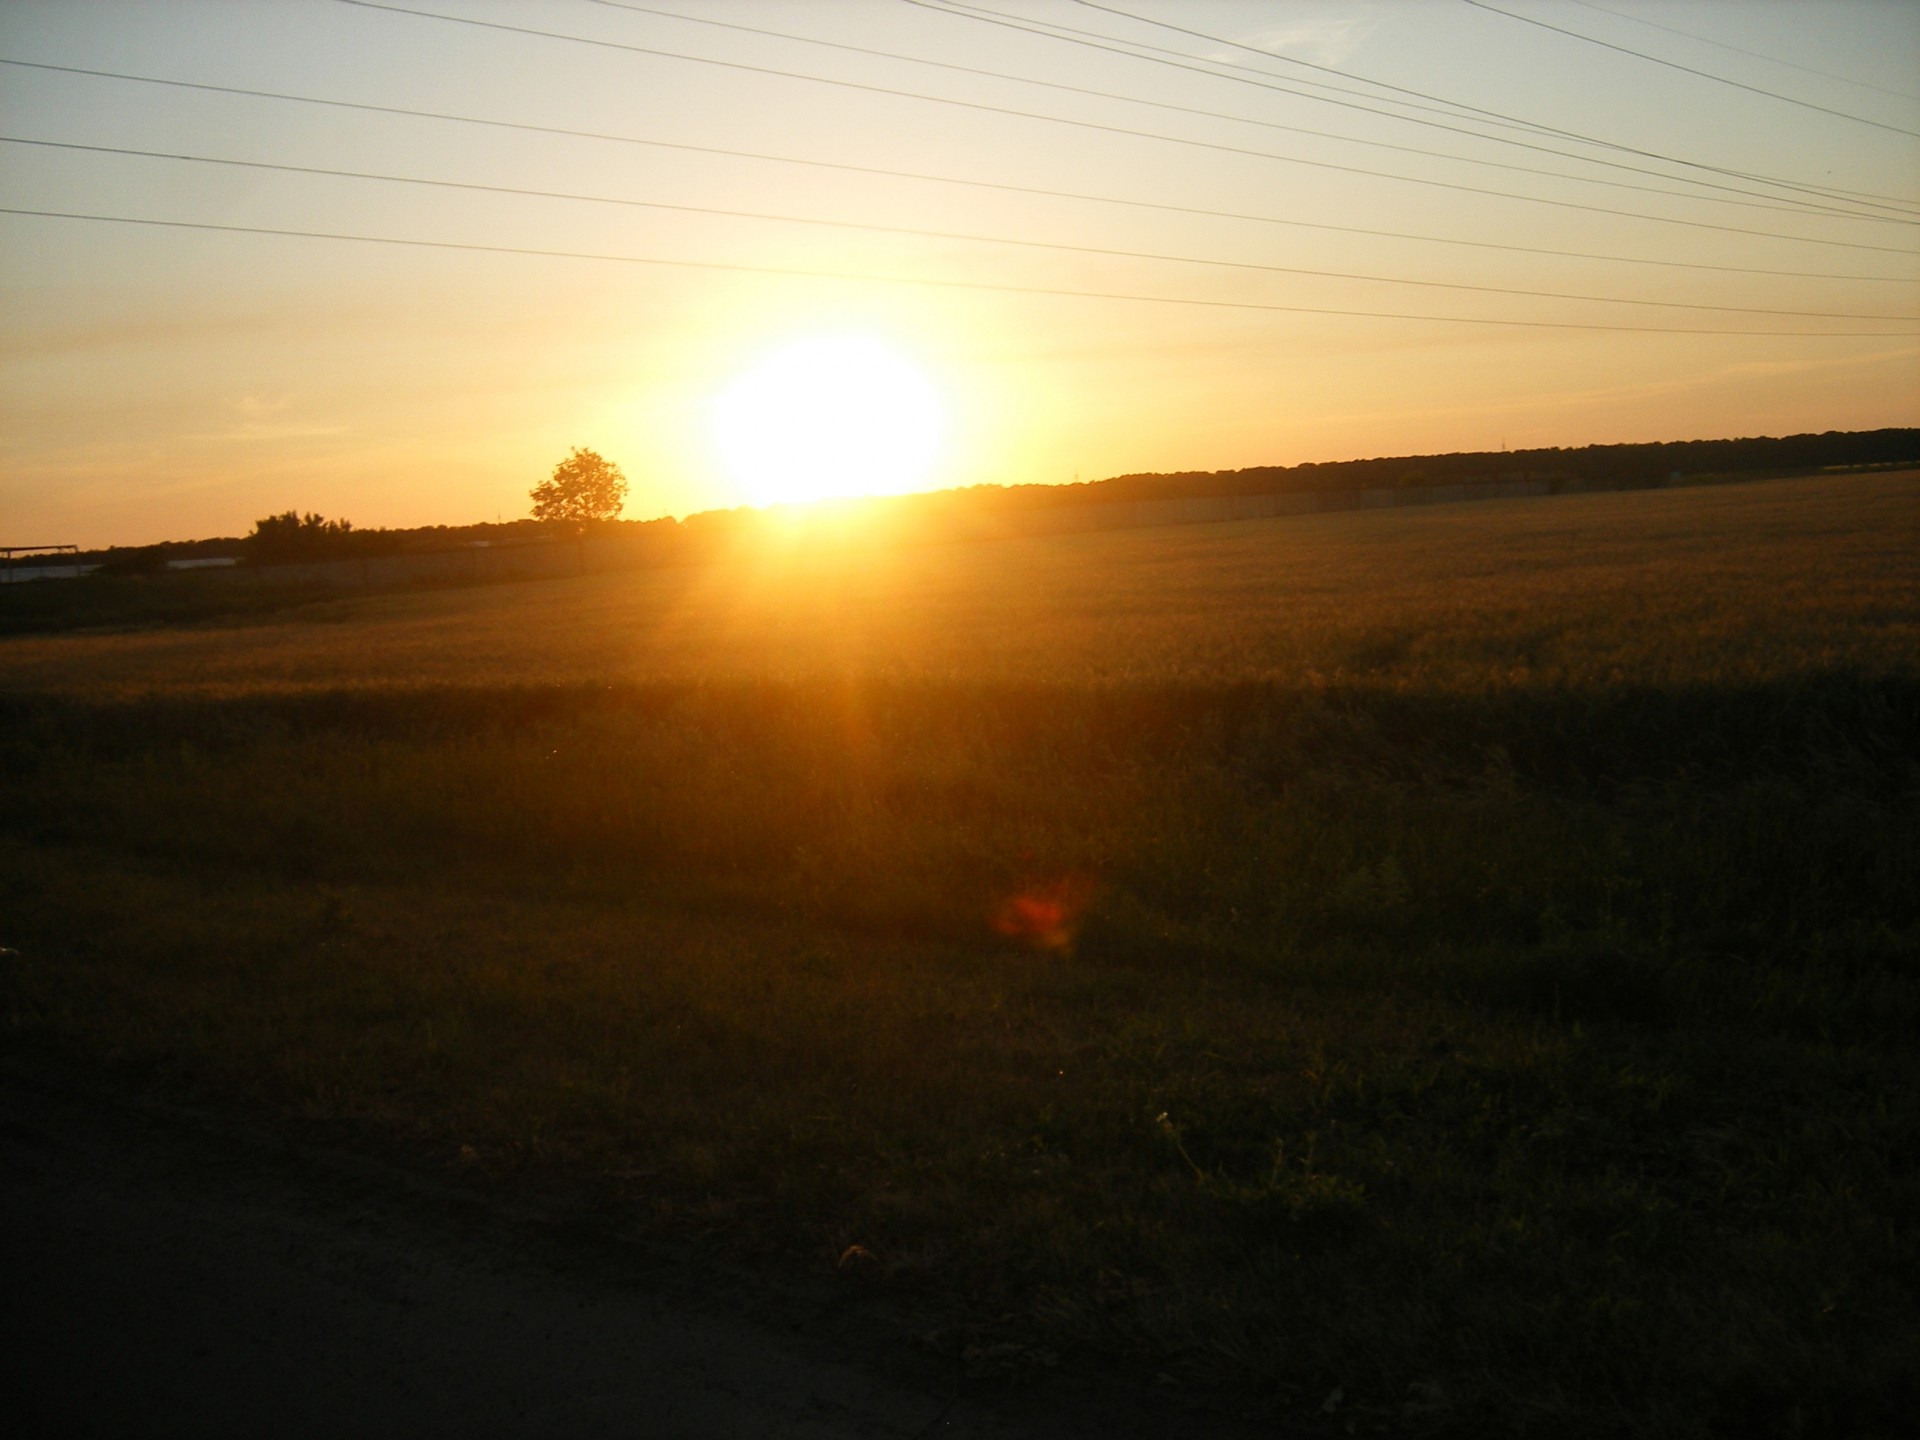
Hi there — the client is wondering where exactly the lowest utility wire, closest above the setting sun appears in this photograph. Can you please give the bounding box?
[0,205,1920,340]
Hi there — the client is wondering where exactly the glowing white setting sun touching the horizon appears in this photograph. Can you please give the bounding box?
[712,334,947,505]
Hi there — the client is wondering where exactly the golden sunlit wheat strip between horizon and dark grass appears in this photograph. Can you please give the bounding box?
[0,472,1920,695]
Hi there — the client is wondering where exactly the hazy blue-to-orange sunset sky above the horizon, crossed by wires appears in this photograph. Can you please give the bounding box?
[0,0,1920,545]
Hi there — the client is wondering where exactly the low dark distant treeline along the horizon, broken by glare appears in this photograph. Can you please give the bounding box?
[60,428,1920,574]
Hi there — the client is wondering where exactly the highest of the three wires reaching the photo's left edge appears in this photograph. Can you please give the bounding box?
[0,56,1920,284]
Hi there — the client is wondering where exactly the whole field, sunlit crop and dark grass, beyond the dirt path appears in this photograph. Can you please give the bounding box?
[0,472,1920,1436]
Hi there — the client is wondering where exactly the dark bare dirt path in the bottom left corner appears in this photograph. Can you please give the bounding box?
[0,1062,1274,1440]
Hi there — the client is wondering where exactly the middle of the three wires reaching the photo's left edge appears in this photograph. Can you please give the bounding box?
[11,134,1920,324]
